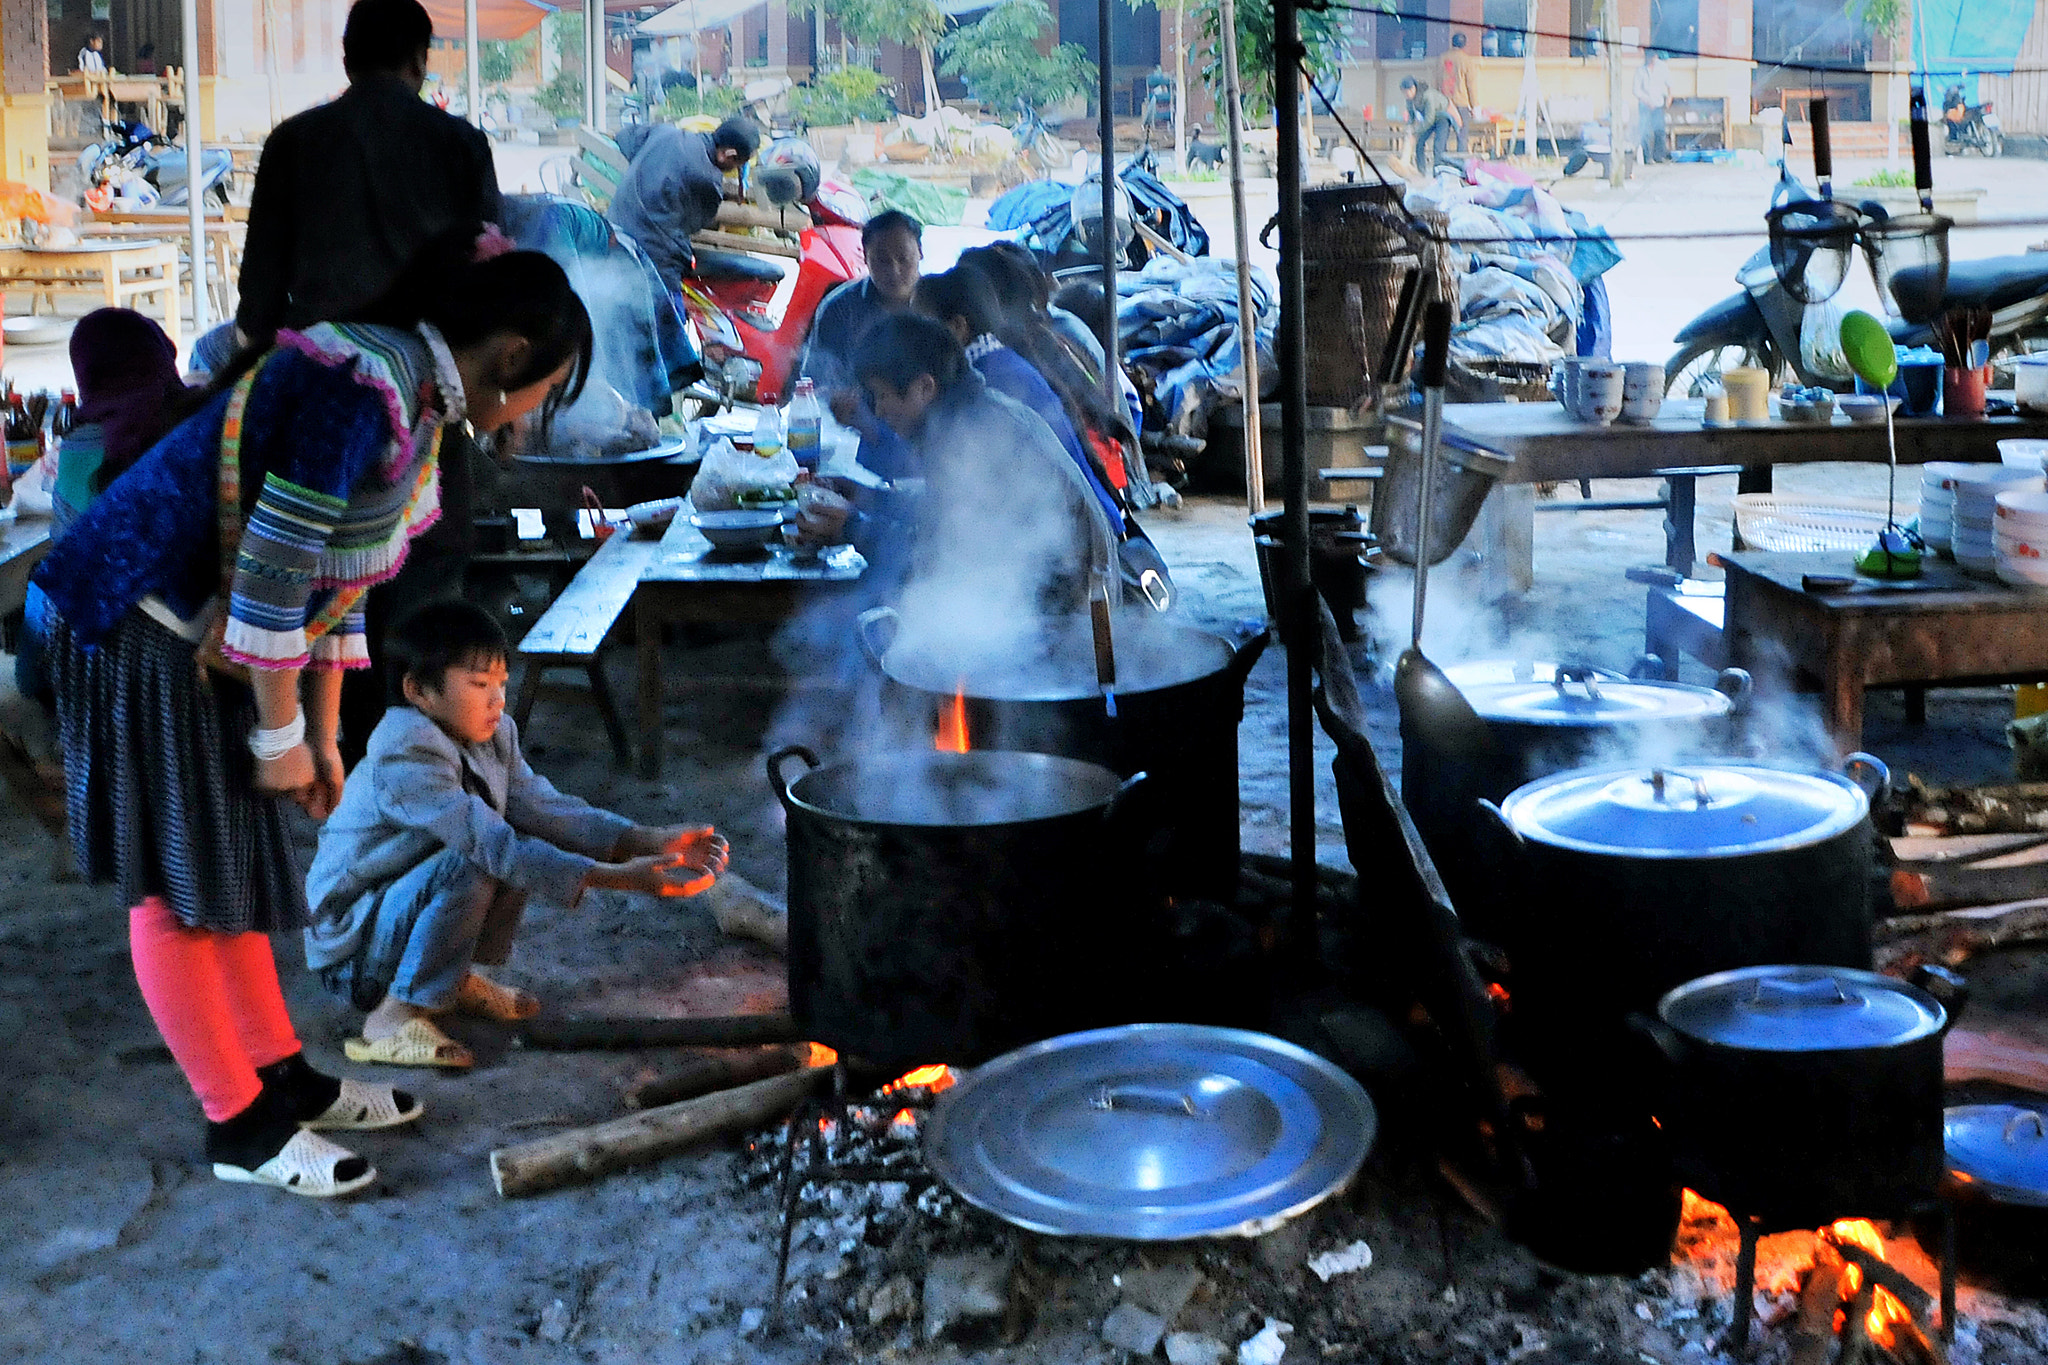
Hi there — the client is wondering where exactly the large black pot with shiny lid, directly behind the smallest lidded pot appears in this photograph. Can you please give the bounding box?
[1481,755,1886,1046]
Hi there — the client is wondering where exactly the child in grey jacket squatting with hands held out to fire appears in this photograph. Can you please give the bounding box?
[305,602,727,1068]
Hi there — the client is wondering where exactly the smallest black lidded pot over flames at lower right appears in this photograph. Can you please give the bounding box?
[1638,966,1962,1232]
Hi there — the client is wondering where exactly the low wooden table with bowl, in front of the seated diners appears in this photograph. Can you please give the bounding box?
[626,516,868,778]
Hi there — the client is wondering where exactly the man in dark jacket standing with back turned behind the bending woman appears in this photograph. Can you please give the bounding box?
[236,0,500,759]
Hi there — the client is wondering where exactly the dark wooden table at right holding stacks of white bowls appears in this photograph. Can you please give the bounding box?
[1718,551,2048,751]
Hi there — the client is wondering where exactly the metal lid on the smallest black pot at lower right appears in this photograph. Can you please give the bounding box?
[1657,966,1948,1052]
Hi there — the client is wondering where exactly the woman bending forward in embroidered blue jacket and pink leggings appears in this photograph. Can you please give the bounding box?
[37,233,592,1195]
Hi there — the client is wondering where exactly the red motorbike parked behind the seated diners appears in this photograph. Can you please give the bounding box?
[680,154,868,405]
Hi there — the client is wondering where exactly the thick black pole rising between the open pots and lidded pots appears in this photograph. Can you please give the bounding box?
[1274,0,1319,941]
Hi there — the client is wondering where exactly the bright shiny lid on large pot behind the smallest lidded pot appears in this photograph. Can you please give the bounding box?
[1501,763,1870,857]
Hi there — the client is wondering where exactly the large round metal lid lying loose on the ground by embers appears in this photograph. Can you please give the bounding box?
[924,1023,1378,1242]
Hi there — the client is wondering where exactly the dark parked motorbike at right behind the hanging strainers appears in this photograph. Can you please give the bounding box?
[1665,139,2048,397]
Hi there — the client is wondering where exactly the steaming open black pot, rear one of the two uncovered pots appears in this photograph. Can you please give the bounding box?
[860,608,1268,905]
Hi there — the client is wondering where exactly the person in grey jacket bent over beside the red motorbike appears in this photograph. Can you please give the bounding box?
[606,115,762,293]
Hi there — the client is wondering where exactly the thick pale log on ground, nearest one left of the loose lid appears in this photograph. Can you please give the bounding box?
[492,1066,831,1199]
